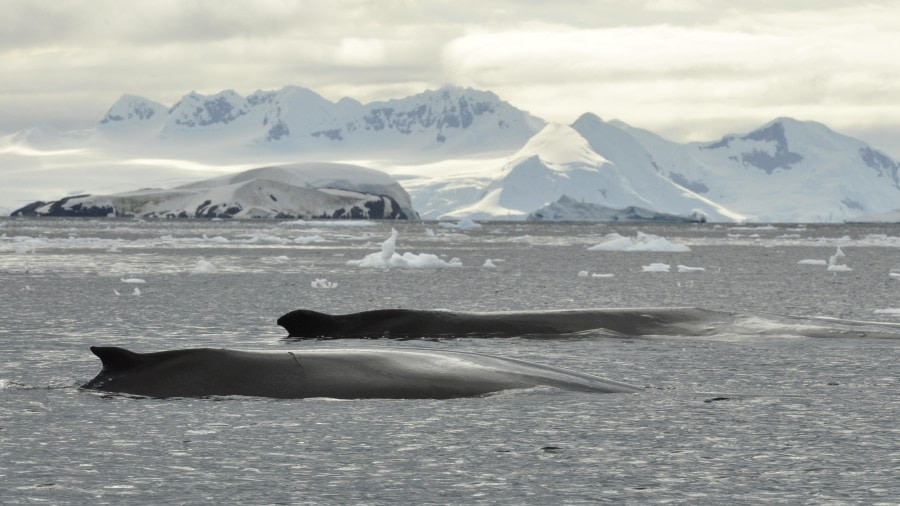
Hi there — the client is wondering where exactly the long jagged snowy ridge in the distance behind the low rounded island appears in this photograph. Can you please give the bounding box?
[96,86,544,157]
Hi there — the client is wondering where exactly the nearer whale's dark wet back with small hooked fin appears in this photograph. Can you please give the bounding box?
[82,346,640,399]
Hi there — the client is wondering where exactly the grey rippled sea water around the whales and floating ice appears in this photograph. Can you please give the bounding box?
[0,219,900,504]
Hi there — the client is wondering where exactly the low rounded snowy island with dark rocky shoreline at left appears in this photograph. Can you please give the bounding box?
[12,163,418,219]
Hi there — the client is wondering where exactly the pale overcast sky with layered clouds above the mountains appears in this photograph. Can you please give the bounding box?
[0,0,900,157]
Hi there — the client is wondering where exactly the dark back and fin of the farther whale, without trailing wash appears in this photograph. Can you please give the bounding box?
[278,308,734,339]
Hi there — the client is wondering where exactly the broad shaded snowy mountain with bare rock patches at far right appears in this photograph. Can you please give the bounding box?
[616,118,900,222]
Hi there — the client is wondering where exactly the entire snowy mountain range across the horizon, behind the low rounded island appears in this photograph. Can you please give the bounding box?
[0,86,900,222]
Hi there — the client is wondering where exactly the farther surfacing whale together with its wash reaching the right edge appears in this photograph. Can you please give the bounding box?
[278,307,900,339]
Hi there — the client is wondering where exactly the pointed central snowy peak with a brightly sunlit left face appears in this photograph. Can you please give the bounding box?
[445,114,743,221]
